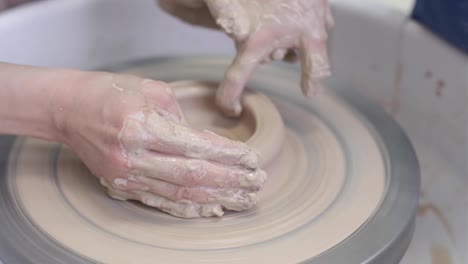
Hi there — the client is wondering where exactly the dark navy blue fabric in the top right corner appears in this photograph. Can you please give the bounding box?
[412,0,468,53]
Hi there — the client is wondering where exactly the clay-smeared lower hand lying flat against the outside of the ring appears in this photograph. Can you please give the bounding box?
[62,73,266,218]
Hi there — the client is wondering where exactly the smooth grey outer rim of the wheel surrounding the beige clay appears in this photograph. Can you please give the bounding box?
[0,57,420,264]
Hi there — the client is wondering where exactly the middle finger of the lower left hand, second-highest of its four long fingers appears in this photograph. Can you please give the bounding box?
[130,152,266,191]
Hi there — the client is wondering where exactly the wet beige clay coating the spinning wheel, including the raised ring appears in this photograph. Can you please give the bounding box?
[11,81,386,263]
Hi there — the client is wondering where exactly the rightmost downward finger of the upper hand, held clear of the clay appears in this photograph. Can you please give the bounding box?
[300,36,330,97]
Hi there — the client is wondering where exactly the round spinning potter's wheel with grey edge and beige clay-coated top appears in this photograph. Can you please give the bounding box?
[0,58,419,263]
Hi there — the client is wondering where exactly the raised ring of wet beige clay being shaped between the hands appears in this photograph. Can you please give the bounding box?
[170,81,285,167]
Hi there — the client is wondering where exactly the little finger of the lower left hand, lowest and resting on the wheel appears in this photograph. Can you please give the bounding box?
[107,188,224,218]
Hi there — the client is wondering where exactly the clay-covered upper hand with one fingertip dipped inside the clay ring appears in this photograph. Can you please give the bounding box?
[159,0,333,116]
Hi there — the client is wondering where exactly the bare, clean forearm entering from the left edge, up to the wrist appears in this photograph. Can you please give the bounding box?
[0,62,76,141]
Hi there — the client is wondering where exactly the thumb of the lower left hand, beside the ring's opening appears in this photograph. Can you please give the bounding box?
[141,79,185,122]
